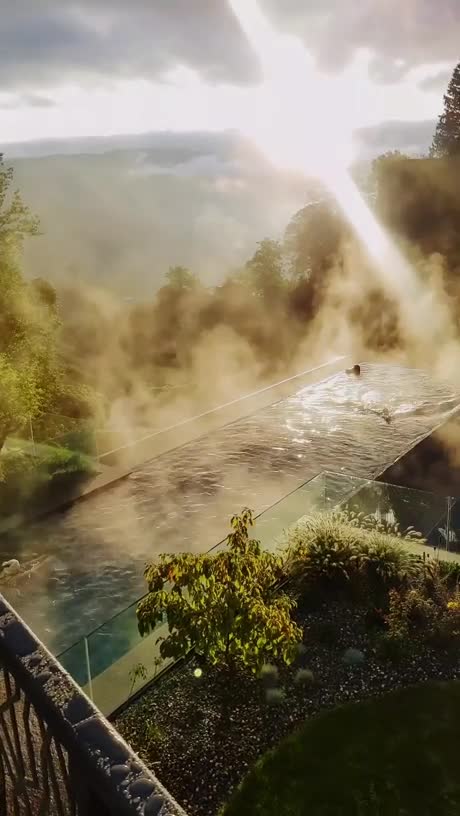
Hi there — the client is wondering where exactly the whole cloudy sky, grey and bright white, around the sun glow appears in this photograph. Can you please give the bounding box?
[0,0,460,156]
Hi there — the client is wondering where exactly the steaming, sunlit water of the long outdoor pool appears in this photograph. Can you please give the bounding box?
[2,365,460,652]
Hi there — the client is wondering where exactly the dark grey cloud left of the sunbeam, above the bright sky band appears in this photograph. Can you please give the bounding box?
[0,0,259,89]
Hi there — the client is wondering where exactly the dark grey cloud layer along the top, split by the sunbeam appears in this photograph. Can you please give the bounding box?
[0,0,460,90]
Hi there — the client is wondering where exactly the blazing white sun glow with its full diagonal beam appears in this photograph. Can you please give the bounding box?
[230,0,418,306]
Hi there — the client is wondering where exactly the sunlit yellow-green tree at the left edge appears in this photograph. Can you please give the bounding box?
[0,156,57,450]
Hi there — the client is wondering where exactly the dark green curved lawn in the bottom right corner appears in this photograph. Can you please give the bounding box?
[222,682,460,816]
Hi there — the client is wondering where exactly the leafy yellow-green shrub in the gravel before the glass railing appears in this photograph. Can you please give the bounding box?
[137,510,301,672]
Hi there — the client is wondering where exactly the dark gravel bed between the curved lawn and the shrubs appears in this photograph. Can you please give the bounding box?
[116,604,460,816]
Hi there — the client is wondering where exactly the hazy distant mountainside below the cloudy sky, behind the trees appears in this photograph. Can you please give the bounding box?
[0,122,433,299]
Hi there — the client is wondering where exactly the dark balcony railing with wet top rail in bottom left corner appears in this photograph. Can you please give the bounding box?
[0,595,186,816]
